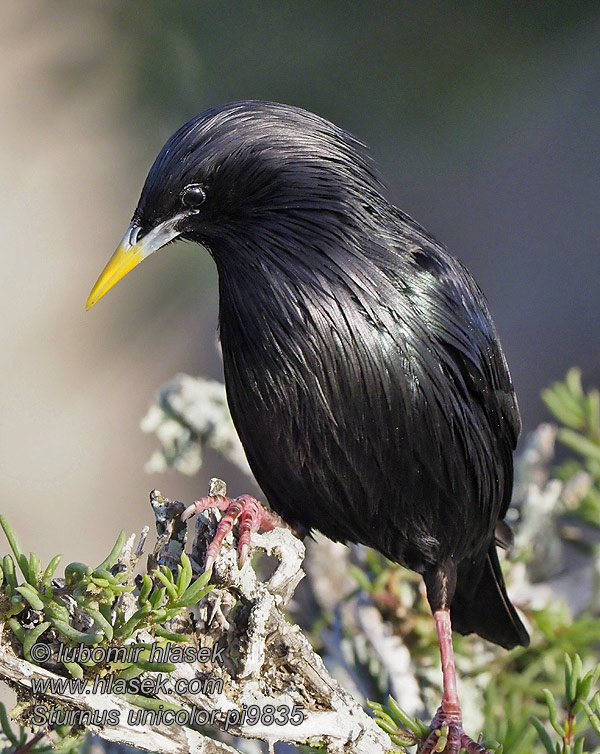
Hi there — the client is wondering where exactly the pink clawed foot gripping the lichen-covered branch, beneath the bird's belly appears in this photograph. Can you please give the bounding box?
[181,494,289,570]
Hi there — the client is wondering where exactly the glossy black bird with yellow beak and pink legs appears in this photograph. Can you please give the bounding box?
[88,101,529,752]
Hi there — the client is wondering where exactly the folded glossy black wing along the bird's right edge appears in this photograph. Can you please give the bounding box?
[384,220,521,519]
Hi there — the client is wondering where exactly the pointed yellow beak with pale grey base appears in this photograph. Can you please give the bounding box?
[85,215,181,310]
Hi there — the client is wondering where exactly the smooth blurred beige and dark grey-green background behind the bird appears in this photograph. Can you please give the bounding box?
[0,0,600,562]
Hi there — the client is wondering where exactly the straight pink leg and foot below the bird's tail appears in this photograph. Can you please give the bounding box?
[421,608,489,754]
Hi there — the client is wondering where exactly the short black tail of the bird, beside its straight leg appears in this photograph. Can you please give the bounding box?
[450,543,529,649]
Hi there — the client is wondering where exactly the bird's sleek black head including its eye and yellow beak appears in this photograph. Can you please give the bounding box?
[86,101,381,309]
